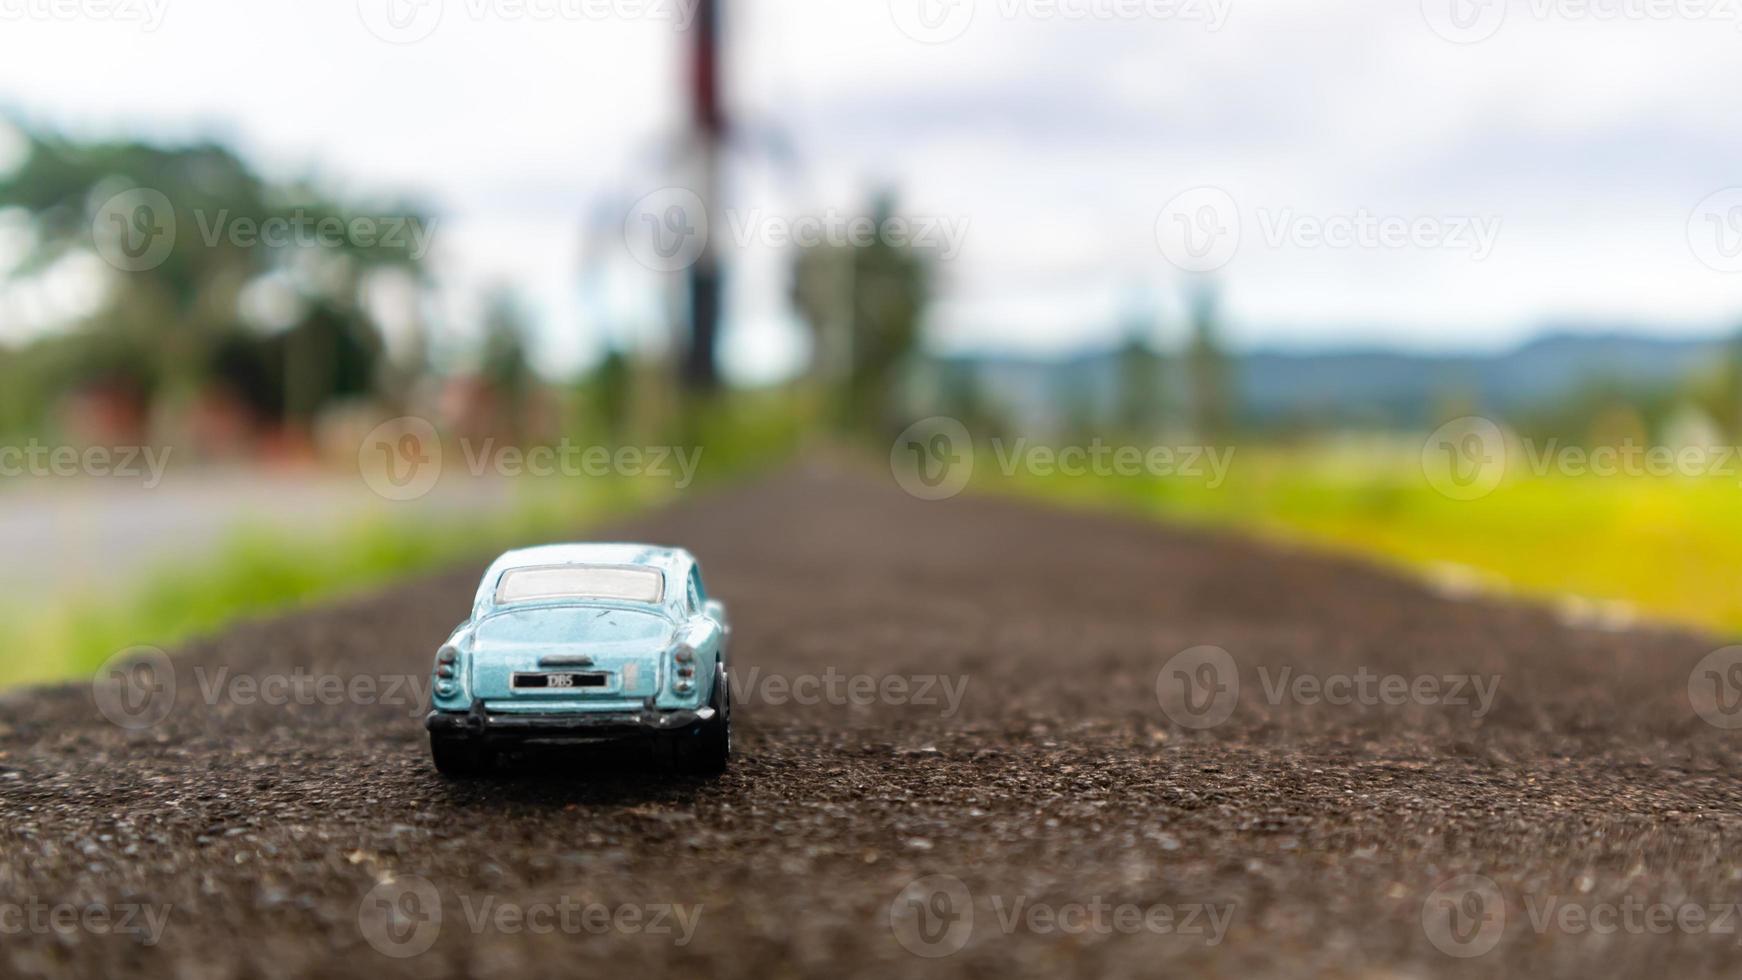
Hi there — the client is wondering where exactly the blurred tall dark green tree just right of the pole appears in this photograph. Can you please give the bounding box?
[793,193,932,430]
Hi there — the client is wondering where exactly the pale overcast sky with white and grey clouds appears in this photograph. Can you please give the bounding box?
[0,0,1742,378]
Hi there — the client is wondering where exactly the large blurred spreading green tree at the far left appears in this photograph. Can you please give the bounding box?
[0,120,429,445]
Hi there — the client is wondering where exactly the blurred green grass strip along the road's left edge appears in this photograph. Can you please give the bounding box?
[0,395,810,688]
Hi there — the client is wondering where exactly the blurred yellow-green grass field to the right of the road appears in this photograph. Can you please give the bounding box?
[996,446,1742,634]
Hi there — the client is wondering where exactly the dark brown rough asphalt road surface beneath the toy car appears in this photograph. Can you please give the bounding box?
[0,468,1742,980]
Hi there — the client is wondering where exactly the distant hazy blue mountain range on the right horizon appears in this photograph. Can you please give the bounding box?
[937,332,1737,426]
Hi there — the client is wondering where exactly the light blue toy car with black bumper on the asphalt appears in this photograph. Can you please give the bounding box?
[425,545,732,776]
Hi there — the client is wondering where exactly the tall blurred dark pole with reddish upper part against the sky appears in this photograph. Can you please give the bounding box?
[683,0,726,392]
